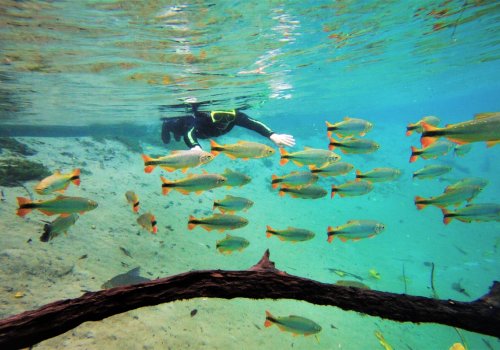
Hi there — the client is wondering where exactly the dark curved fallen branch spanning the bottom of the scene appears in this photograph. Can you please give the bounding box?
[0,250,500,349]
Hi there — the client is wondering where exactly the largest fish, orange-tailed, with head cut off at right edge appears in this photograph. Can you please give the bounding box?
[420,112,500,147]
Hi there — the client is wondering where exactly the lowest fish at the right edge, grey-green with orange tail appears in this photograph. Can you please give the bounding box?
[442,203,500,225]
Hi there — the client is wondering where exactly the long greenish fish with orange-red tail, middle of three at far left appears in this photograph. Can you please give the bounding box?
[17,196,97,216]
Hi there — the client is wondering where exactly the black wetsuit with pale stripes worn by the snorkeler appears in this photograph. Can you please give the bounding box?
[162,110,274,148]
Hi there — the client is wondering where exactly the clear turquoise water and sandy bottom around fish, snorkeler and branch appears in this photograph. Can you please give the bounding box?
[0,1,500,349]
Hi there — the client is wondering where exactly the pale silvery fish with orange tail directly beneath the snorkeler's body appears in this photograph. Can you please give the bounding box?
[142,150,214,173]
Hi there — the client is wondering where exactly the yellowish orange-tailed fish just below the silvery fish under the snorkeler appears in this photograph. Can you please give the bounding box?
[160,173,226,195]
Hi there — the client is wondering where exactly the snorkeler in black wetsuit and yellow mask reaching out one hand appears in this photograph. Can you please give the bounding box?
[161,99,295,150]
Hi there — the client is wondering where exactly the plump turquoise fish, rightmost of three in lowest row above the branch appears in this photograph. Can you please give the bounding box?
[327,220,385,243]
